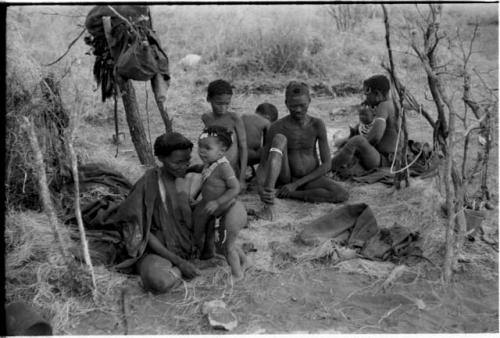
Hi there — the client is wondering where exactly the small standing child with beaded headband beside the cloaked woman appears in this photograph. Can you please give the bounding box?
[189,126,247,280]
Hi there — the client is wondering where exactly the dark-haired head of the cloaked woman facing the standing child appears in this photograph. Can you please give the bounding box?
[154,132,193,177]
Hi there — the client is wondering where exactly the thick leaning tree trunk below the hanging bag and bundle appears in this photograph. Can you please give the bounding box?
[120,80,155,166]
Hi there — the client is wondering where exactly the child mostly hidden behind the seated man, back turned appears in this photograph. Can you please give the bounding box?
[241,102,278,175]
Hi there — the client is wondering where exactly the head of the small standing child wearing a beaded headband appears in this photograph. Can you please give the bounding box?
[198,126,233,164]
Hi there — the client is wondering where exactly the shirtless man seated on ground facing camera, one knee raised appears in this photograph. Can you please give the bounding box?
[257,81,348,220]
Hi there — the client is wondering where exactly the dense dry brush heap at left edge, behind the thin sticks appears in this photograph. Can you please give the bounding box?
[5,19,68,210]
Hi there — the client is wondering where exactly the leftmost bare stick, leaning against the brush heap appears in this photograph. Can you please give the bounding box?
[22,117,69,264]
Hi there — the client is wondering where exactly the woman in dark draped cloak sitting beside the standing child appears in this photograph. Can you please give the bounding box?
[112,133,199,293]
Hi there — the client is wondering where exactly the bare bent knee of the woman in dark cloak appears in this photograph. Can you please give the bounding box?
[138,254,181,293]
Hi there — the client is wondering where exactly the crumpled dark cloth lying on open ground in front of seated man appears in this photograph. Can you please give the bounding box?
[298,203,422,261]
